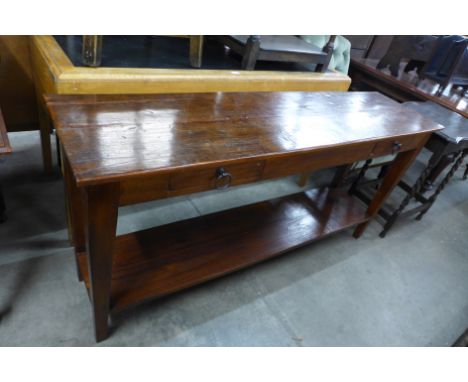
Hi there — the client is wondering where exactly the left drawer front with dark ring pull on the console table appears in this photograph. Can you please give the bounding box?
[169,161,265,196]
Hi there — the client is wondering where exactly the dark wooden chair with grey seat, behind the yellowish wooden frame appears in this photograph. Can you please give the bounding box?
[212,35,336,72]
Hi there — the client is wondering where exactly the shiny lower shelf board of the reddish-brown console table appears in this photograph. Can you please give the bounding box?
[79,188,367,311]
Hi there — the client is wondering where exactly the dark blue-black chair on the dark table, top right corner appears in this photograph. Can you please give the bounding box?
[421,35,468,95]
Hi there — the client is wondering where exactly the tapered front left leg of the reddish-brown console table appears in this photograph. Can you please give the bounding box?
[86,183,119,342]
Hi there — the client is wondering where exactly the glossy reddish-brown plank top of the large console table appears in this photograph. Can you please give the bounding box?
[46,92,443,186]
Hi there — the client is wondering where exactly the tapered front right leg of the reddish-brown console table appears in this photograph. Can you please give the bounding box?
[353,147,425,238]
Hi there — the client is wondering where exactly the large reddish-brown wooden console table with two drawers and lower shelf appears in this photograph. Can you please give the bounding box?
[46,92,442,341]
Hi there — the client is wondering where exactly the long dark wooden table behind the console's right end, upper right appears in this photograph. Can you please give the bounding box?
[349,58,468,118]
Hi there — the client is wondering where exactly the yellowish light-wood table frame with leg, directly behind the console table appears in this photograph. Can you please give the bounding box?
[31,36,351,172]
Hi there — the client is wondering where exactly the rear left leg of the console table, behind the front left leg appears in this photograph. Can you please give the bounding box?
[62,155,86,281]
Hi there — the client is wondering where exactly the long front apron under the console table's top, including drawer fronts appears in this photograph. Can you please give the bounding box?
[119,134,427,206]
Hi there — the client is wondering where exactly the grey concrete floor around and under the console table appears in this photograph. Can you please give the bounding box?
[0,132,468,346]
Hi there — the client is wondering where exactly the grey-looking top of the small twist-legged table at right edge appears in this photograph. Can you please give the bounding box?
[403,101,468,144]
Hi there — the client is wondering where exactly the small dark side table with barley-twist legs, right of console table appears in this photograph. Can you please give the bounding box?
[355,101,468,237]
